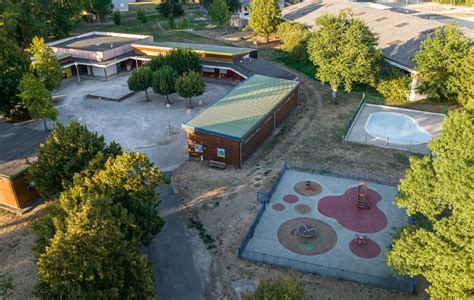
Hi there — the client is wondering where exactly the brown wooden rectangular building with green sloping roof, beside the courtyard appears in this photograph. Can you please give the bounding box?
[182,75,299,167]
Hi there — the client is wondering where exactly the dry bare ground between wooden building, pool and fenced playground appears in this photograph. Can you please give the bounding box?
[173,62,427,299]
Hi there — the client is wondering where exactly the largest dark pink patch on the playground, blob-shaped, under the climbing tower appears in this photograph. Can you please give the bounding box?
[318,187,387,233]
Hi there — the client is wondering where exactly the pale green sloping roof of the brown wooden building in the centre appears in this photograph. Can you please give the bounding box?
[183,75,299,140]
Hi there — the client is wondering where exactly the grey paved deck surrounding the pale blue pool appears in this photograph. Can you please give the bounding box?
[345,103,445,154]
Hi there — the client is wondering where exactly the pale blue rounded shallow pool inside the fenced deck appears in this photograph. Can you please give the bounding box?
[365,112,433,145]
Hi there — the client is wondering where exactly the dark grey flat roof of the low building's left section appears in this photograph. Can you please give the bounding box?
[52,34,141,51]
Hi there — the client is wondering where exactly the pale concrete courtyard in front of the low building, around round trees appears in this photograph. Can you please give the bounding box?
[25,76,233,171]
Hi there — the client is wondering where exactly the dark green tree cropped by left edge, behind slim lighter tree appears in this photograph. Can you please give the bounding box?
[0,30,30,117]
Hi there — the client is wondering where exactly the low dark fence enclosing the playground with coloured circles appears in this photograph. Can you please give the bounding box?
[237,162,416,293]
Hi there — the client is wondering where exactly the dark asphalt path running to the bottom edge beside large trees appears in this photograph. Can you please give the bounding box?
[147,185,204,300]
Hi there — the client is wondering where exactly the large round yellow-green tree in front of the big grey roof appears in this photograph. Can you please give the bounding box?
[307,10,380,103]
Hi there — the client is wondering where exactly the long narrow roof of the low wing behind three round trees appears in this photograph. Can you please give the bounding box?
[132,42,256,56]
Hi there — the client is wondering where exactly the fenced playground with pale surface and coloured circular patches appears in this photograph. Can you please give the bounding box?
[239,170,412,292]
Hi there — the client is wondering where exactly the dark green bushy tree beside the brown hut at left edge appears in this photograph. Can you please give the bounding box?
[28,121,121,199]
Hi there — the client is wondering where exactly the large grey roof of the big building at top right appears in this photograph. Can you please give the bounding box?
[282,0,474,71]
